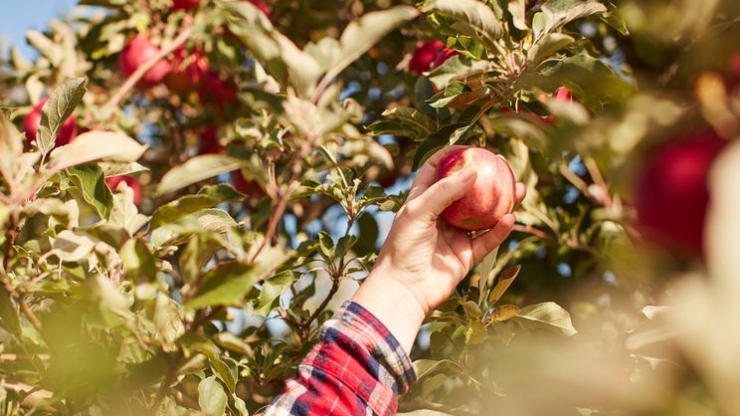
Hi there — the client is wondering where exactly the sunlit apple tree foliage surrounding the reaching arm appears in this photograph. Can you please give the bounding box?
[0,0,740,415]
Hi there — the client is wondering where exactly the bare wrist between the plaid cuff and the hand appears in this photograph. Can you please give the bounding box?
[352,269,426,354]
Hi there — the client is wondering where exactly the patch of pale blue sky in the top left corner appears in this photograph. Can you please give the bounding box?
[0,0,77,56]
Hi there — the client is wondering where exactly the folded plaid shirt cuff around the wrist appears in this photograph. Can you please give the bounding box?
[330,301,416,394]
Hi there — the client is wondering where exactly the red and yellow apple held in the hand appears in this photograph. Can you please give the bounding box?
[436,146,516,231]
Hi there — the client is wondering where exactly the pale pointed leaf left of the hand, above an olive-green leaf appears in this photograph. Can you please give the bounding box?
[157,155,245,195]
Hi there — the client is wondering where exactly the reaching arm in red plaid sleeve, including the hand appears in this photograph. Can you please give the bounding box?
[265,147,524,416]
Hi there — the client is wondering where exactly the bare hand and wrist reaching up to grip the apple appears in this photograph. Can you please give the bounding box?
[353,146,526,351]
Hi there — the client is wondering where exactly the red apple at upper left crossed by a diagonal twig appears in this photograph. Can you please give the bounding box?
[118,34,172,87]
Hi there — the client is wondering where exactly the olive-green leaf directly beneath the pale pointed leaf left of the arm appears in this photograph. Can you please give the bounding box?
[150,184,243,230]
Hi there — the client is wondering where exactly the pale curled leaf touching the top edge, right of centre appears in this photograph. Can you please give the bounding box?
[421,0,504,43]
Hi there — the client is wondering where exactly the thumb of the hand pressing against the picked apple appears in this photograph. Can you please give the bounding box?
[412,167,478,222]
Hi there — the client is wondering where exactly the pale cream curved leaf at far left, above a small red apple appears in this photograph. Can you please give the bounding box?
[49,131,147,171]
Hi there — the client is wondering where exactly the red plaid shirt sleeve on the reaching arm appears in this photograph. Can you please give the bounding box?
[260,302,416,416]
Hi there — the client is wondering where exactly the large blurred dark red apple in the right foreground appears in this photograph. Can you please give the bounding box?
[634,132,727,256]
